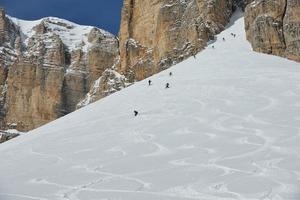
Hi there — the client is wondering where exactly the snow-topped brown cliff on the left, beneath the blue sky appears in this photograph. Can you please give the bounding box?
[0,10,119,131]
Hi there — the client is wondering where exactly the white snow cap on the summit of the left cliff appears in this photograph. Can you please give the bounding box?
[9,17,113,52]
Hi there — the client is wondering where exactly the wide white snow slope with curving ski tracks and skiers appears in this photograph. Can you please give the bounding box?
[0,12,300,200]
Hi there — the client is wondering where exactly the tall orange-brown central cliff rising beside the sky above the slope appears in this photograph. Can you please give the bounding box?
[119,0,233,81]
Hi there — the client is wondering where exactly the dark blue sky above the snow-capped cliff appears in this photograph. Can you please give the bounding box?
[0,0,123,34]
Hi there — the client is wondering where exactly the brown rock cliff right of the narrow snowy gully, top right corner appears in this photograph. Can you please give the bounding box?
[245,0,300,62]
